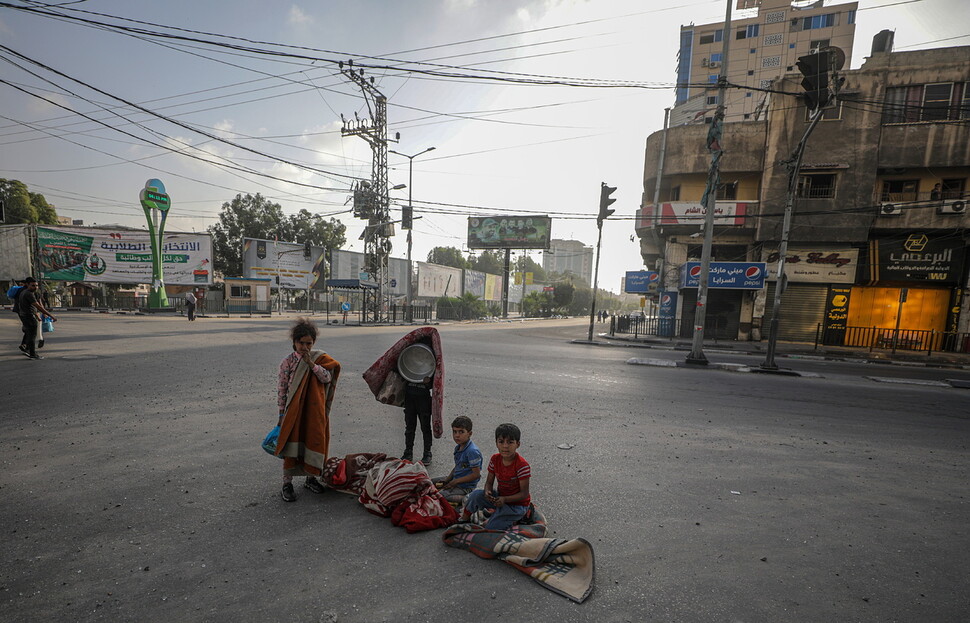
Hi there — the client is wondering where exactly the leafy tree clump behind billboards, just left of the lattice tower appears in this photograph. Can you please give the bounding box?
[209,193,347,276]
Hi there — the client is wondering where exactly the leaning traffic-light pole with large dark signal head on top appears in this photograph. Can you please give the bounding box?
[761,47,845,372]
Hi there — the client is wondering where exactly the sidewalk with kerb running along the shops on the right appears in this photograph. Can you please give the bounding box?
[576,333,970,370]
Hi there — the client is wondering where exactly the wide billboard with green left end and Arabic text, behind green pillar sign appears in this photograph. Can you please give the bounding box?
[37,227,212,285]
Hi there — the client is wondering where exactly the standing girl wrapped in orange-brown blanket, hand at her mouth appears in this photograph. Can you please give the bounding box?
[276,318,340,502]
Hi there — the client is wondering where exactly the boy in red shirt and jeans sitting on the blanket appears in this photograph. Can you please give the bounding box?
[461,424,532,530]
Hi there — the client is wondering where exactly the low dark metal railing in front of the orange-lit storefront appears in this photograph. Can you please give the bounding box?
[815,323,970,355]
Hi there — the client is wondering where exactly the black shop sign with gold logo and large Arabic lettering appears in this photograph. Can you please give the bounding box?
[869,232,965,284]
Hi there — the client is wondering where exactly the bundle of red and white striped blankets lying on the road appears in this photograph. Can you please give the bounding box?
[323,454,458,533]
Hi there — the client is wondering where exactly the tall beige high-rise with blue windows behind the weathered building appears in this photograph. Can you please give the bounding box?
[670,0,858,125]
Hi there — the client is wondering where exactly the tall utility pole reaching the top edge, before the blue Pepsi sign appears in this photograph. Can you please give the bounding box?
[687,0,733,366]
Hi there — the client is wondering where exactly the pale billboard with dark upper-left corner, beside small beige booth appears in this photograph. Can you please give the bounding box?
[243,238,326,290]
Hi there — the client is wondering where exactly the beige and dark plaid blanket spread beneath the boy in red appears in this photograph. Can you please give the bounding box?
[441,510,595,603]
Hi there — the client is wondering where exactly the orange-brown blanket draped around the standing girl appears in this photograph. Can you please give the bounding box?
[276,350,340,476]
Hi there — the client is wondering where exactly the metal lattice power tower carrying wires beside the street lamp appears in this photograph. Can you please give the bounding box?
[339,61,394,322]
